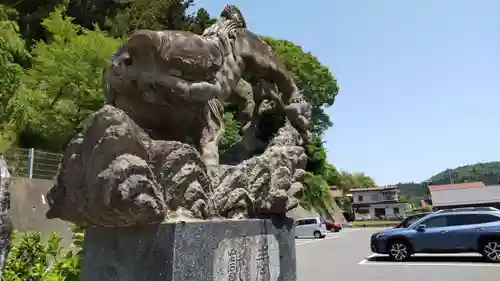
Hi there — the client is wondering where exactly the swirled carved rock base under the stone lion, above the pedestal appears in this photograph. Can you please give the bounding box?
[47,105,307,227]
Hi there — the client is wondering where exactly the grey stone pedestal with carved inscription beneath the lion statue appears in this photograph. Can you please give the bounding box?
[81,219,297,281]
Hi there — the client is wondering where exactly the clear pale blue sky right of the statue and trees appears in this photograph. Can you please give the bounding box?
[196,0,500,184]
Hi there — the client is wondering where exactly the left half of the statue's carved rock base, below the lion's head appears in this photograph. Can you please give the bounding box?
[47,105,209,226]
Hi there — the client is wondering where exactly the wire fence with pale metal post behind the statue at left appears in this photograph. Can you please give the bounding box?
[4,148,62,179]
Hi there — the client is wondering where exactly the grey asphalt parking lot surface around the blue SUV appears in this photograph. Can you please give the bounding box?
[296,228,500,281]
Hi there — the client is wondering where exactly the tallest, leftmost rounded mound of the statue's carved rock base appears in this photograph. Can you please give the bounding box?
[47,105,161,226]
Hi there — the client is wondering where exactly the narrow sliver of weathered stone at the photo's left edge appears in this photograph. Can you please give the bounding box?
[0,156,13,280]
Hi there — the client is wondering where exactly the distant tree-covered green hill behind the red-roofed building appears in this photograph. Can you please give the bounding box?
[396,161,500,205]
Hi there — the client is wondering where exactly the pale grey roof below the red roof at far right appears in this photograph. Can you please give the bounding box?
[431,185,500,207]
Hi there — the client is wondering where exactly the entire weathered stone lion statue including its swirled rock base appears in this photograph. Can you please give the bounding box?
[47,5,311,227]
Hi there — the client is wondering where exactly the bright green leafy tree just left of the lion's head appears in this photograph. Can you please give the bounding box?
[14,6,120,152]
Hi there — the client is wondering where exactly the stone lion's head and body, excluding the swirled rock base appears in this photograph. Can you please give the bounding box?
[104,5,310,165]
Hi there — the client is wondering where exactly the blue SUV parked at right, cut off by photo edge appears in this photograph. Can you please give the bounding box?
[371,207,500,262]
